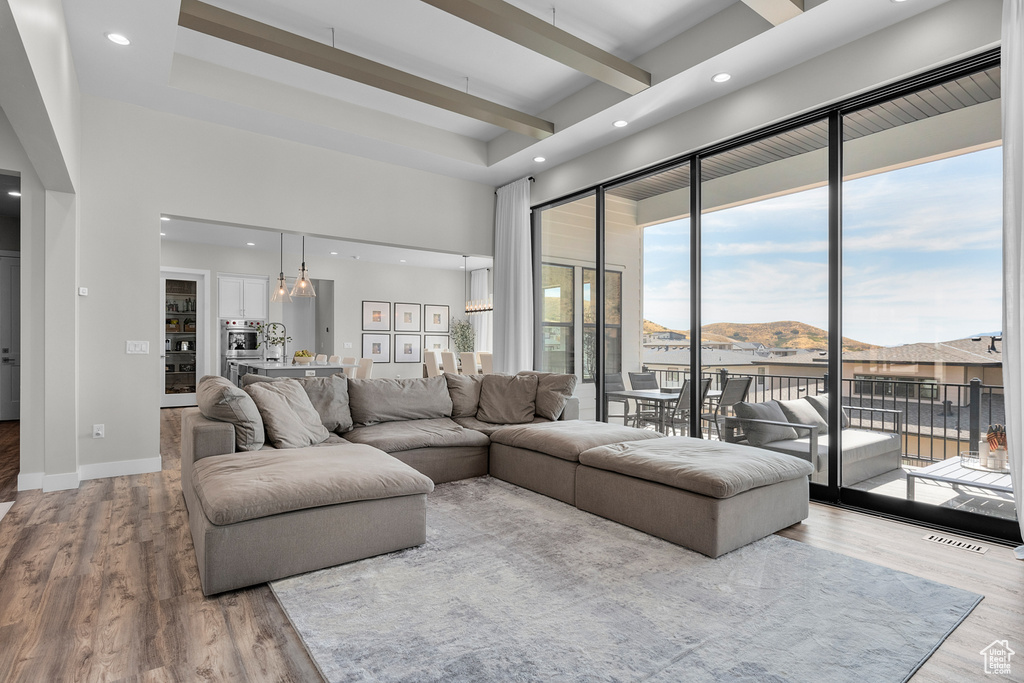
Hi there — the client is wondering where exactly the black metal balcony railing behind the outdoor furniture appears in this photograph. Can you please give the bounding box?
[644,366,1005,465]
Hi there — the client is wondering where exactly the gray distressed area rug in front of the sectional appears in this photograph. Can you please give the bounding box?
[271,477,982,683]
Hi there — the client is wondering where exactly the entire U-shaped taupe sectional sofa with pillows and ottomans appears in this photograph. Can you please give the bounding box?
[181,373,811,595]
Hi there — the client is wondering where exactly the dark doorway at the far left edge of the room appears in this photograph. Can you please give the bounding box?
[0,175,22,504]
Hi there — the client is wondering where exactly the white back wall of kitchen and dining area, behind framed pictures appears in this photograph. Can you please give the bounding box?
[158,240,465,384]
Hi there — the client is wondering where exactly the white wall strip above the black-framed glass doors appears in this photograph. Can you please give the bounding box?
[530,0,1002,204]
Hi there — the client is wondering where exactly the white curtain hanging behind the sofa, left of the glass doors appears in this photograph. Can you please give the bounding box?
[494,178,534,374]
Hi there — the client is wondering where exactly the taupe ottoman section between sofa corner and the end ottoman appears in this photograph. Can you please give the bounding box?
[489,420,663,505]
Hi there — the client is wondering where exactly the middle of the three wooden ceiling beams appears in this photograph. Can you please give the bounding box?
[423,0,650,95]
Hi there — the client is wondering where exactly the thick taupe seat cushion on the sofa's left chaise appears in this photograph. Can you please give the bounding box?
[193,443,434,525]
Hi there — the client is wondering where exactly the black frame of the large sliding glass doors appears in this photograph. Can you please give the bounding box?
[531,48,1022,544]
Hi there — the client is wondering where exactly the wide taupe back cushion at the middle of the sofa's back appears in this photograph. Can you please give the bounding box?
[348,376,452,425]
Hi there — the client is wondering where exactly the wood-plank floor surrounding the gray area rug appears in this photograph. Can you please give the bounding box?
[0,410,1024,683]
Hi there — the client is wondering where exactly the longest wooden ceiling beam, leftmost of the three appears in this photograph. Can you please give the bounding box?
[178,0,555,140]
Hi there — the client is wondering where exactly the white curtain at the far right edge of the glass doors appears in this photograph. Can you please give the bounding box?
[1001,0,1024,559]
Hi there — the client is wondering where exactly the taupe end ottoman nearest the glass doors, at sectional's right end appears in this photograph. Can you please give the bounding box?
[575,436,813,557]
